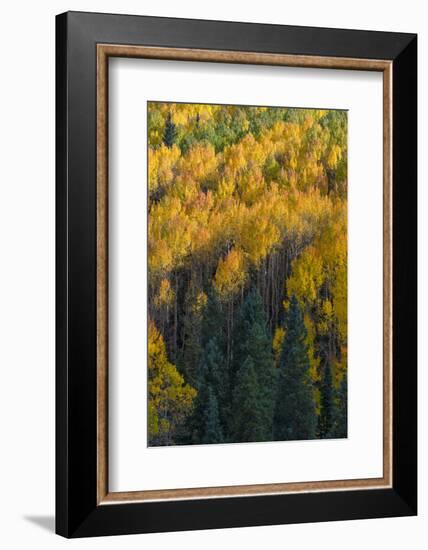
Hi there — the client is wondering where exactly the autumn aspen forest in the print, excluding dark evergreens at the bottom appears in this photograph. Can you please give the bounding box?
[148,103,347,444]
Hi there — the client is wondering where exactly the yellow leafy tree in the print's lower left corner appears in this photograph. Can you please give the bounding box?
[148,321,197,444]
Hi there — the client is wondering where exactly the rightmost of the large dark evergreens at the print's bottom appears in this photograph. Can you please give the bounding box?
[273,295,316,441]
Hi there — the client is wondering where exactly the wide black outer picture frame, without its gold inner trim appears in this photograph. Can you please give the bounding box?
[56,12,417,537]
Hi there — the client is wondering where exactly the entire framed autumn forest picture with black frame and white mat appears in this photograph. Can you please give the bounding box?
[56,12,417,537]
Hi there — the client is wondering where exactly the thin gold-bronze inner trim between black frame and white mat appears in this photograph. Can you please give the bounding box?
[96,44,392,505]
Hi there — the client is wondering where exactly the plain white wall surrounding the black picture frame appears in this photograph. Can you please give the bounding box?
[0,0,422,550]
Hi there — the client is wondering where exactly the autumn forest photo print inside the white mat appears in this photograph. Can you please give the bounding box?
[147,101,348,447]
